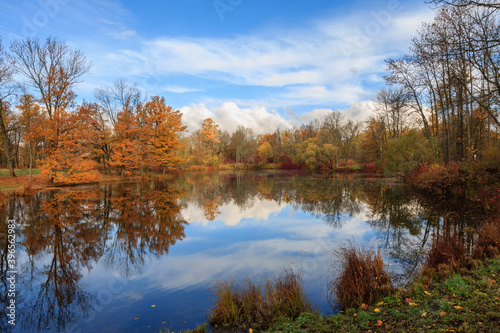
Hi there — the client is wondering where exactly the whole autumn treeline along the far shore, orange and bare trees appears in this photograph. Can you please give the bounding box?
[0,1,500,183]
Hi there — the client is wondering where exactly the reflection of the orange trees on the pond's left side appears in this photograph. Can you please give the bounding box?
[0,180,187,331]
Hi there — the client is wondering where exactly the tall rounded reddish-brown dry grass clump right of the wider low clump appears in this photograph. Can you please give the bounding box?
[328,245,393,310]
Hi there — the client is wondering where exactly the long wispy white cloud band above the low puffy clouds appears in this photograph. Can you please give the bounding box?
[93,5,433,110]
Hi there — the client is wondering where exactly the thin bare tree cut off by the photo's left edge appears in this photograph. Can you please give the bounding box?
[0,38,16,177]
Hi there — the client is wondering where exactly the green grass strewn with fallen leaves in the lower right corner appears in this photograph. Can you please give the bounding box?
[268,258,500,332]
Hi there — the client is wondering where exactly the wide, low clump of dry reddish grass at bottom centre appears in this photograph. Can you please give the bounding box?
[208,269,314,329]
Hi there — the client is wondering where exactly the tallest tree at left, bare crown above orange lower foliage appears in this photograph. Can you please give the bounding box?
[10,37,91,181]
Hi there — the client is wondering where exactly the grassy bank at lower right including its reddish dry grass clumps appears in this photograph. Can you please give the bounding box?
[184,214,500,332]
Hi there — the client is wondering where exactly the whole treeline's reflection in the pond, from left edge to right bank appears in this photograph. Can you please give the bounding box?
[0,173,486,331]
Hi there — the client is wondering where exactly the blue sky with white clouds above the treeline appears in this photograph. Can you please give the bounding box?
[0,0,434,133]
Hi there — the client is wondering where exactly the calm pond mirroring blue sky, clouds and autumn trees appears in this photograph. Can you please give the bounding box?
[0,172,484,332]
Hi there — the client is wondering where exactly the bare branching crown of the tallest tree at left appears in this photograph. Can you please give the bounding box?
[10,37,91,119]
